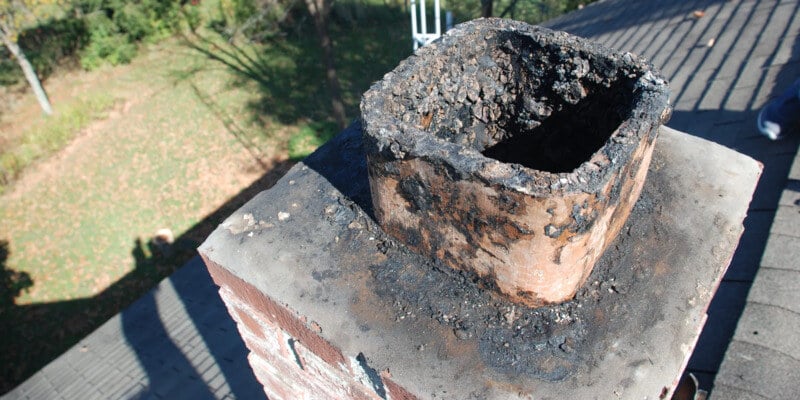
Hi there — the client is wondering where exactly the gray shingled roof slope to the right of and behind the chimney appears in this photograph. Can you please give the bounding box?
[546,0,800,399]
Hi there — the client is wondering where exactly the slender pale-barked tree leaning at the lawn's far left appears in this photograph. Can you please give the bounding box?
[0,0,53,115]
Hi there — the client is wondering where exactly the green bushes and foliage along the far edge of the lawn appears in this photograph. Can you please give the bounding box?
[0,0,593,85]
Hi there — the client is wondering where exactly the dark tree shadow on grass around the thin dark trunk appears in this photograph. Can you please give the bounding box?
[177,1,411,130]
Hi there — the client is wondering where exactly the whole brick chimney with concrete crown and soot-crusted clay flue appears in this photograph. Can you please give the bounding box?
[199,19,761,400]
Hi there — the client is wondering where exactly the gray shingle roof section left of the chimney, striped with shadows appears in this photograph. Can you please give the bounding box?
[3,259,264,399]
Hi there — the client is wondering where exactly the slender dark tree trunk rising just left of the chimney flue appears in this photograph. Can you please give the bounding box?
[305,0,347,129]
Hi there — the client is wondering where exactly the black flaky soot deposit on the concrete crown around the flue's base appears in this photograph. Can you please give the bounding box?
[370,173,671,381]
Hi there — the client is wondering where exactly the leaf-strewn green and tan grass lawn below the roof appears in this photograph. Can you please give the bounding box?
[0,3,410,393]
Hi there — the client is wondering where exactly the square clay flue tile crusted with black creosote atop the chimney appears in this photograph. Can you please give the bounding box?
[361,19,670,306]
